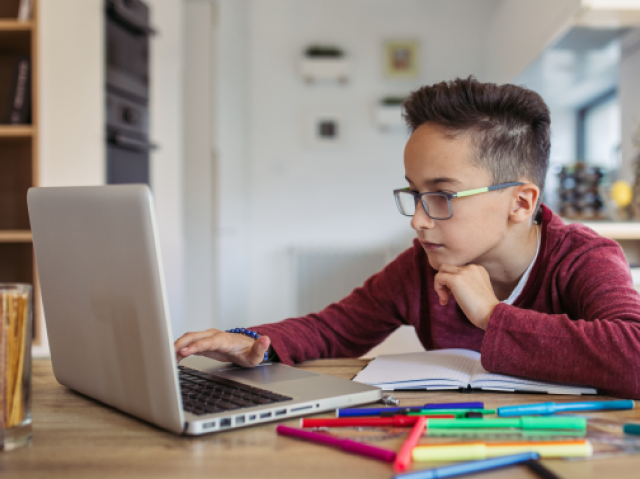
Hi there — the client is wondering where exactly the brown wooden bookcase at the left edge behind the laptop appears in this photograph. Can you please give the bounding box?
[0,0,46,348]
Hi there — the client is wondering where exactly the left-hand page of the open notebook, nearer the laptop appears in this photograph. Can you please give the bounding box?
[353,349,480,387]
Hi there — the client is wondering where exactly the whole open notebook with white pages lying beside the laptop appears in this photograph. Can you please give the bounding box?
[353,349,598,394]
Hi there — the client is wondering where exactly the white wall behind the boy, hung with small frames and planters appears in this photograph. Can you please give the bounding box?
[216,0,495,327]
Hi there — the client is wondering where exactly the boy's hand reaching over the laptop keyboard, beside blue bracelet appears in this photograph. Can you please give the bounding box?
[174,329,271,368]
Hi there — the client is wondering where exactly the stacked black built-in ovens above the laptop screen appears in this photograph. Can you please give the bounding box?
[105,0,155,184]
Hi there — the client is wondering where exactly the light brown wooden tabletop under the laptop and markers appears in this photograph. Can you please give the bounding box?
[0,359,640,479]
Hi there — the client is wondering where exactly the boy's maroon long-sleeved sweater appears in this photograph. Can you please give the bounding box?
[252,205,640,398]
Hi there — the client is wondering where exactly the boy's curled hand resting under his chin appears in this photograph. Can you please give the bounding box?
[435,264,500,329]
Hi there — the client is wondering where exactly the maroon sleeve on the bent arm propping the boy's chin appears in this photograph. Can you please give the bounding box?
[481,240,640,399]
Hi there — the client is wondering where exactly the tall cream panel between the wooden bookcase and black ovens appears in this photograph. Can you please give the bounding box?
[37,0,105,186]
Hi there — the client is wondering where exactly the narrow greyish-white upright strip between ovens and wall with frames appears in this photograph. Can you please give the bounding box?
[183,0,218,336]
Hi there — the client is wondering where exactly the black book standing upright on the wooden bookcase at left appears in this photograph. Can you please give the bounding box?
[0,55,31,125]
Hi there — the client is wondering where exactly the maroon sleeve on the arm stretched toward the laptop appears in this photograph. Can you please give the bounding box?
[251,247,423,364]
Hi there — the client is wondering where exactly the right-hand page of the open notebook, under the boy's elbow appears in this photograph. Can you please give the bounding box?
[469,361,597,394]
